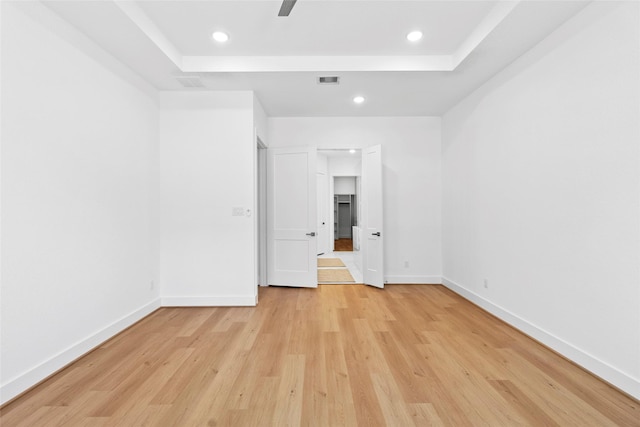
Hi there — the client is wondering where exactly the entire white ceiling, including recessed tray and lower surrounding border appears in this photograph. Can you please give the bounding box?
[45,0,587,117]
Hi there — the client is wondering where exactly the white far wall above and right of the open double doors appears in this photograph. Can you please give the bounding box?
[269,117,441,283]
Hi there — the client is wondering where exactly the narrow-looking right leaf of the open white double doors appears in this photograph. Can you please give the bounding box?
[361,145,384,288]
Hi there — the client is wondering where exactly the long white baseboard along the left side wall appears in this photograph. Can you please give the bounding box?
[0,298,160,405]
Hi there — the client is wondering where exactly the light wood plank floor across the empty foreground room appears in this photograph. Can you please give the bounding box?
[0,285,640,427]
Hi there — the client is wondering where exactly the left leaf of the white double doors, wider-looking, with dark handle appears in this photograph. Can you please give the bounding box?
[267,147,318,288]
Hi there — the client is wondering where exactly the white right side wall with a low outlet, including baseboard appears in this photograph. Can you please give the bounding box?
[443,2,640,397]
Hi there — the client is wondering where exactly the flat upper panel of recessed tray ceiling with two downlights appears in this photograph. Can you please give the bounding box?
[139,0,492,56]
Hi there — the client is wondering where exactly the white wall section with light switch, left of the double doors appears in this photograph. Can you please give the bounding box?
[160,92,257,305]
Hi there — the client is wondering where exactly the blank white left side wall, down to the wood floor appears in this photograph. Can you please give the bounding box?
[0,2,159,403]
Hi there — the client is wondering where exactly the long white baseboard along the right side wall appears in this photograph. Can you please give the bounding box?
[442,277,640,399]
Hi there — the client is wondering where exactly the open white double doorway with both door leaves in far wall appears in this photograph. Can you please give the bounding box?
[266,145,384,288]
